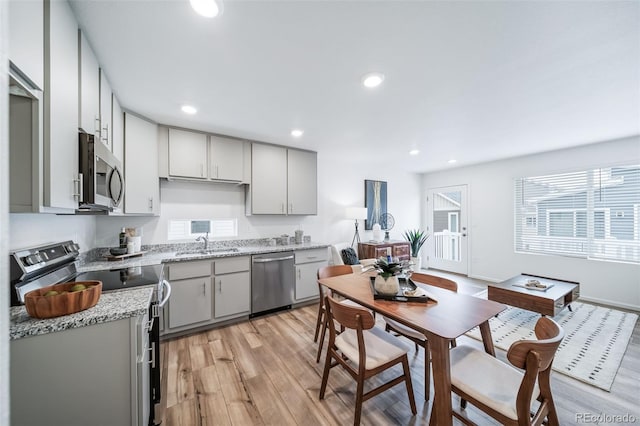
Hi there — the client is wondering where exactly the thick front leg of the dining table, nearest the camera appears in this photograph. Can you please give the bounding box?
[427,333,453,426]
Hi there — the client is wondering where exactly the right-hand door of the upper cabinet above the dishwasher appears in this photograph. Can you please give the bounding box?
[287,149,318,214]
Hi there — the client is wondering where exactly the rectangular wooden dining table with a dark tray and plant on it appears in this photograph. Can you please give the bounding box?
[318,273,506,426]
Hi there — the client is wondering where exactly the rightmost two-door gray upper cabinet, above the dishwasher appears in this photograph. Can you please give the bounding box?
[247,143,318,215]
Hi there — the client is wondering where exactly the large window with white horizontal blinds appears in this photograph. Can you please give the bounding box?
[515,165,640,263]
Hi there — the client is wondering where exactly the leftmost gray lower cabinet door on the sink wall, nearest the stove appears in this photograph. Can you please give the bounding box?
[169,277,212,328]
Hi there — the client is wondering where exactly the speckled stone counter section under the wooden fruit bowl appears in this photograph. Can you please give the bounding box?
[9,286,153,340]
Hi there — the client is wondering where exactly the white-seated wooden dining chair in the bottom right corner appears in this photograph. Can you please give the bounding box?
[451,317,564,426]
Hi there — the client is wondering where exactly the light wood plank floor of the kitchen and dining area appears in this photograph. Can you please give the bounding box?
[157,277,640,426]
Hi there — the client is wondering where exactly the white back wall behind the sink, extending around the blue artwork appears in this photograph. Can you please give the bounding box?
[95,152,421,247]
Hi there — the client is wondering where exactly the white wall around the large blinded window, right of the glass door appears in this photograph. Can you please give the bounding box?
[422,136,640,309]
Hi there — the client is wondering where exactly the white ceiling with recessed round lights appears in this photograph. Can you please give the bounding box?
[72,0,640,172]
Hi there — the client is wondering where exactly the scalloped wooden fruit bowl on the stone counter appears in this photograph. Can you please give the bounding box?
[24,281,102,319]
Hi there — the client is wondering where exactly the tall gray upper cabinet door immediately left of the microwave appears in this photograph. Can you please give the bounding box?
[44,1,79,210]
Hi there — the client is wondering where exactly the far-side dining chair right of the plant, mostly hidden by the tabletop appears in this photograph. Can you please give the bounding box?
[384,273,458,401]
